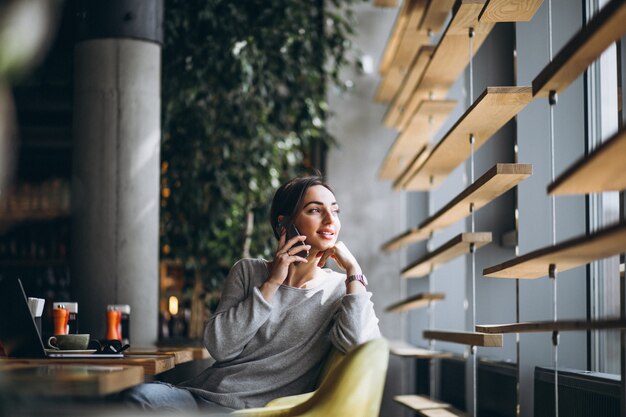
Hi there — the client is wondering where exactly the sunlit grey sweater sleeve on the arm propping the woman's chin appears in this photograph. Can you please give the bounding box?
[330,292,381,352]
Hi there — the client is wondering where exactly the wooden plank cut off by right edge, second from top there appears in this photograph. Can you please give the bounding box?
[548,129,626,195]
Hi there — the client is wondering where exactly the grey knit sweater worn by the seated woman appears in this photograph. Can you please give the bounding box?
[182,259,380,409]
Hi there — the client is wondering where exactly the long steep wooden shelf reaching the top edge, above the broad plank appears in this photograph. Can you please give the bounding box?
[394,0,495,130]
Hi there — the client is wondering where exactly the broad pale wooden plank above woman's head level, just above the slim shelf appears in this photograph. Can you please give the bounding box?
[405,87,532,191]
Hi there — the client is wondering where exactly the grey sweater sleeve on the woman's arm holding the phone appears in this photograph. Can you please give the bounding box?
[204,261,272,362]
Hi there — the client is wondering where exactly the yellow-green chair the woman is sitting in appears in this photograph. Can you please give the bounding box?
[233,339,389,417]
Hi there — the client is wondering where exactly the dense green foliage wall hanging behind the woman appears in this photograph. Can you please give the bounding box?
[161,0,356,290]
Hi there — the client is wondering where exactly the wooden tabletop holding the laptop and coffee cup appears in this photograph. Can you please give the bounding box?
[0,353,176,375]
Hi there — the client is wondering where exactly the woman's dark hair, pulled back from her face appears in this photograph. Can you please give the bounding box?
[270,175,333,239]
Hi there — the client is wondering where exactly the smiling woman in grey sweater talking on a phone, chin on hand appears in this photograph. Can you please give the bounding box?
[120,177,380,409]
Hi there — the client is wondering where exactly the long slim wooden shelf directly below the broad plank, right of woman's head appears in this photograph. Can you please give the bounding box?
[383,164,533,251]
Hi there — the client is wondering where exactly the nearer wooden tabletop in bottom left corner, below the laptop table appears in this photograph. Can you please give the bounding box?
[0,360,144,397]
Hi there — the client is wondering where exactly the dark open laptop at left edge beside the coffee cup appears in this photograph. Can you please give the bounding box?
[0,279,124,359]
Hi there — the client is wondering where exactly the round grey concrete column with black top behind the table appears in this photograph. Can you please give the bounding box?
[71,1,162,346]
